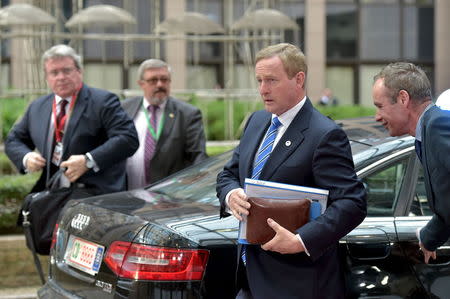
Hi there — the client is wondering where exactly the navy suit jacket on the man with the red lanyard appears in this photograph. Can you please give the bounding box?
[5,85,139,193]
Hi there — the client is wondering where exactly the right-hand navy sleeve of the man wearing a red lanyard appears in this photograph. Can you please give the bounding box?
[90,93,139,169]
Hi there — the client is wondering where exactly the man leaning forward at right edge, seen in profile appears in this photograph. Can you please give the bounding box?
[373,62,450,263]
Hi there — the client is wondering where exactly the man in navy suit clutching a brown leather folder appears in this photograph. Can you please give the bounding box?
[217,44,366,299]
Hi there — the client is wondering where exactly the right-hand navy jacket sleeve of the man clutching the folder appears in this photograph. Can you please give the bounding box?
[297,129,366,260]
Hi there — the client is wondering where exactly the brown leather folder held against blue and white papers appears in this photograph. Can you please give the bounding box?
[246,197,311,244]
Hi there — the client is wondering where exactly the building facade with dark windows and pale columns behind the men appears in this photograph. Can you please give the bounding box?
[1,0,450,106]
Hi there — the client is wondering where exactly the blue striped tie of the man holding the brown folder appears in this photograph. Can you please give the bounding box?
[241,117,281,265]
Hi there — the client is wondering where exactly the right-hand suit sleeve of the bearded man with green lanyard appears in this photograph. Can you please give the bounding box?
[184,109,208,165]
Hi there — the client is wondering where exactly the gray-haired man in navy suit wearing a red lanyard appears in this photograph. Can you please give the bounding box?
[5,45,139,194]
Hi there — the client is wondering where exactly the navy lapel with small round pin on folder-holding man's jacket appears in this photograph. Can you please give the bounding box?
[260,99,312,180]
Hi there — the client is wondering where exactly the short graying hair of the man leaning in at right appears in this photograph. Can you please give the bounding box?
[373,62,431,104]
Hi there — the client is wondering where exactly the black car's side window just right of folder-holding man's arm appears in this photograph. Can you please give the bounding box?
[362,158,408,216]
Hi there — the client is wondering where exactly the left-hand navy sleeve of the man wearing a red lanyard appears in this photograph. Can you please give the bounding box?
[5,107,36,173]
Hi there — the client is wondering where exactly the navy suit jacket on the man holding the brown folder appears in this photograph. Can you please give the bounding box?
[217,99,366,299]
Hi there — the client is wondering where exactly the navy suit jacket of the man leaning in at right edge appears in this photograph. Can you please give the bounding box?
[420,106,450,251]
